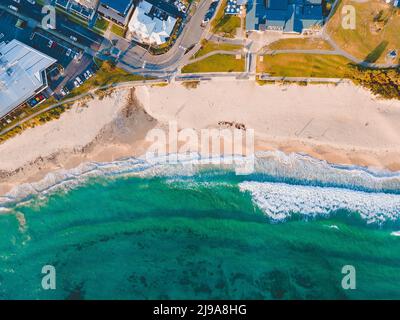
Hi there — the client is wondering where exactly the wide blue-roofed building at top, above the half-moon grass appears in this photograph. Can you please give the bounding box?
[246,0,323,33]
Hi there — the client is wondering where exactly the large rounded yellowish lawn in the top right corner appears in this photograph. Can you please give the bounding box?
[327,0,400,63]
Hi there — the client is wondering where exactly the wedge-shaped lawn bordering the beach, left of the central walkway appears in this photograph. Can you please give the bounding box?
[182,54,244,73]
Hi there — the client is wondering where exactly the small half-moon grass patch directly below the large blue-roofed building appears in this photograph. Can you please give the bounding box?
[268,38,333,50]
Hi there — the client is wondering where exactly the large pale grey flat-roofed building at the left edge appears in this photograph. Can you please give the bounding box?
[0,40,56,118]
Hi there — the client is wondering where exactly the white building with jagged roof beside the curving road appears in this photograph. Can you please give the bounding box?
[128,1,177,45]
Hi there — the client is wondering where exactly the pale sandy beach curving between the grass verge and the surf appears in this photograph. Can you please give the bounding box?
[0,81,400,194]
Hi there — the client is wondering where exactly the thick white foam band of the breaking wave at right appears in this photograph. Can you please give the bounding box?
[239,181,400,223]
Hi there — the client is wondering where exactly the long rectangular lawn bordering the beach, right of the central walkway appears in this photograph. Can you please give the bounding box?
[257,53,350,78]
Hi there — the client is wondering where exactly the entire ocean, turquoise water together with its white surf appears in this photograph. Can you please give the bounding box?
[0,153,400,299]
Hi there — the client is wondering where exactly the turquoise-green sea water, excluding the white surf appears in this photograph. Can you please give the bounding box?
[0,161,400,299]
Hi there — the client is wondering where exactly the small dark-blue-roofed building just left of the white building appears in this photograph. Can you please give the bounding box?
[97,0,134,26]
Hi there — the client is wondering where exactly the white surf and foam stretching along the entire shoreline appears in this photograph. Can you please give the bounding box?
[0,151,400,223]
